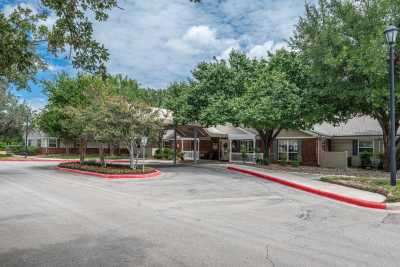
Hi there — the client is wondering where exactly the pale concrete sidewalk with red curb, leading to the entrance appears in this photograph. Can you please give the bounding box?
[228,164,386,207]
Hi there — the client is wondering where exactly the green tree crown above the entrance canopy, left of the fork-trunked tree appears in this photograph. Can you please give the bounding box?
[187,51,259,126]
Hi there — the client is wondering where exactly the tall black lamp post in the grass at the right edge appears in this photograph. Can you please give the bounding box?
[385,26,398,186]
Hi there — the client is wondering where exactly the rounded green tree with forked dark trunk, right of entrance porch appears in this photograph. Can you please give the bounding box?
[236,69,306,162]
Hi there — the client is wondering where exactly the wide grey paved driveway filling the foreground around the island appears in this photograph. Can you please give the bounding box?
[0,162,400,267]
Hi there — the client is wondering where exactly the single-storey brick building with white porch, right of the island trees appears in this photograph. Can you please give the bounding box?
[163,116,394,168]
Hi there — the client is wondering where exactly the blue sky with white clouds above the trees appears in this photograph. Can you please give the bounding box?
[0,0,315,109]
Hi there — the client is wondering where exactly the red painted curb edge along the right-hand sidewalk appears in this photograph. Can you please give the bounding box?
[227,166,387,209]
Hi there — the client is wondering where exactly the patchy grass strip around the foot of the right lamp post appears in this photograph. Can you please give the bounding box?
[321,176,400,202]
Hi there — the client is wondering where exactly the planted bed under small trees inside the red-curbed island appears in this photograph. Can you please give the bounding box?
[58,162,156,174]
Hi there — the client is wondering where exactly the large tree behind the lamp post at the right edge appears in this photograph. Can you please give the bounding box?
[291,0,400,170]
